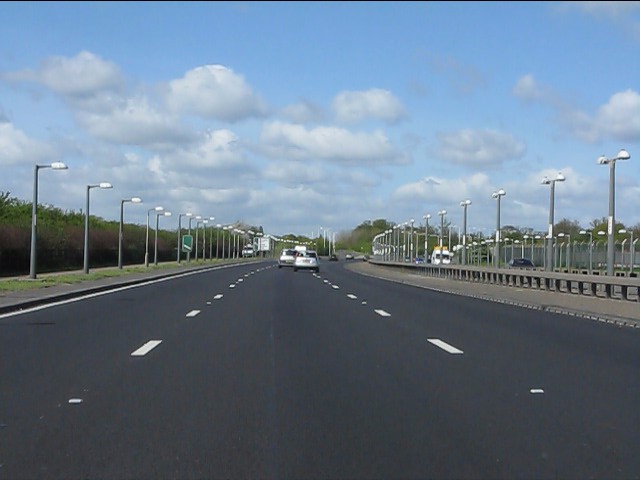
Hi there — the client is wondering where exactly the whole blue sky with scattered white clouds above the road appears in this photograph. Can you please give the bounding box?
[0,2,640,240]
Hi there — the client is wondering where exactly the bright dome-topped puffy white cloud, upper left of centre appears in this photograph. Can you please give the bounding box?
[166,65,267,122]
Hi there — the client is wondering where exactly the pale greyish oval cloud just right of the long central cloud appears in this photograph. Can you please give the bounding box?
[437,129,526,168]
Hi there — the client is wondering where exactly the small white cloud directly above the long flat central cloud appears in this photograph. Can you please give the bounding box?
[332,88,406,123]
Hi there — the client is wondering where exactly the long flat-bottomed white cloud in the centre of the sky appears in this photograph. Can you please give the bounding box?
[260,122,409,165]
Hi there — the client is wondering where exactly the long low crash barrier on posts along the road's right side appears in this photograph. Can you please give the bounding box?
[369,258,640,302]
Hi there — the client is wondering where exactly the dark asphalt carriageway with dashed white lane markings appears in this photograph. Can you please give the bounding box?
[0,262,640,478]
